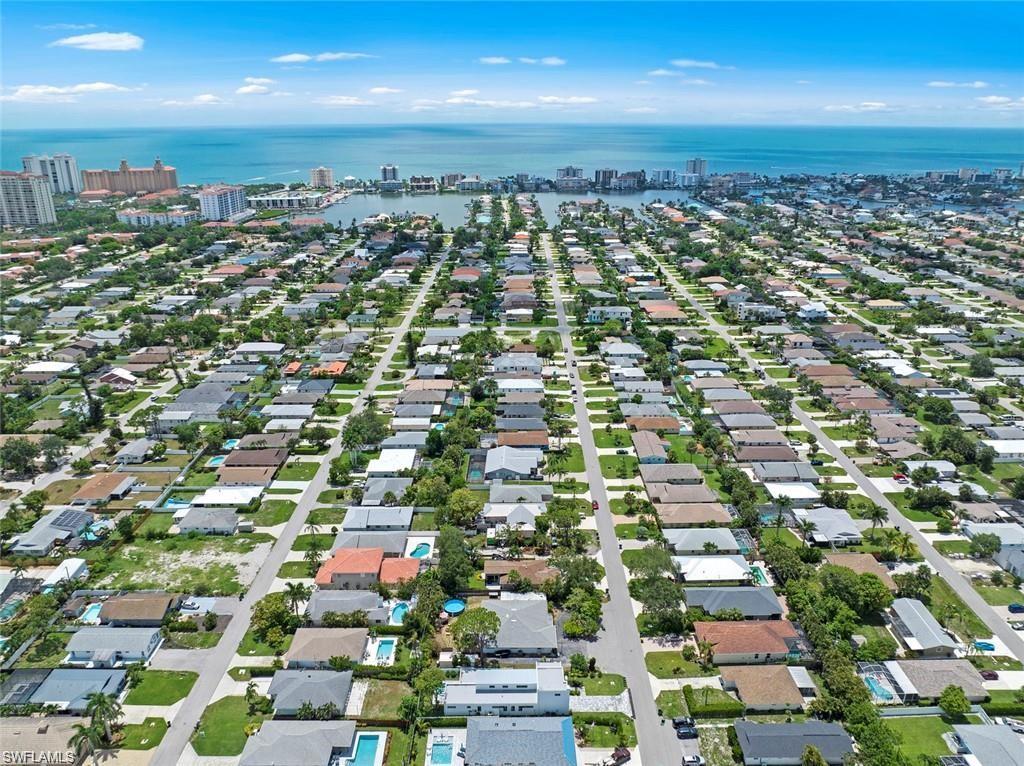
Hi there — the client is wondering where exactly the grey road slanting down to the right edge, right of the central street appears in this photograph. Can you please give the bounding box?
[663,248,1024,659]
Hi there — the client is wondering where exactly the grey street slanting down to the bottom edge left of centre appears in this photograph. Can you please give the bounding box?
[151,249,446,766]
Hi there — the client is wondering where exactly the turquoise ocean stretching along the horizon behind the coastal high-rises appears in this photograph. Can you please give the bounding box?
[0,125,1024,183]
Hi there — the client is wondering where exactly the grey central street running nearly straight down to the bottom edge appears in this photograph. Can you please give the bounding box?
[543,235,682,766]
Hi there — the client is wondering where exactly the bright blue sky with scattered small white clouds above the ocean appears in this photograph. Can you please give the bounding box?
[0,0,1024,128]
